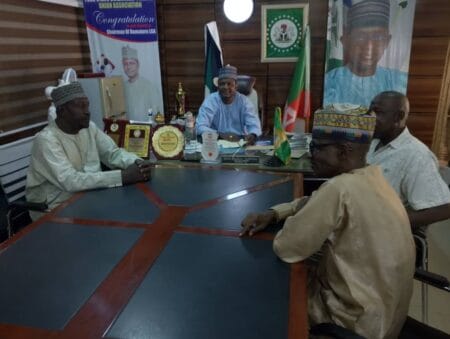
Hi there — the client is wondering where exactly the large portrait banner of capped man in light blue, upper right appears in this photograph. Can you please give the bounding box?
[323,0,416,107]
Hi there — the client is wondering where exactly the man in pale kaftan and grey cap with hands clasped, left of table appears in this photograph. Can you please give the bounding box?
[26,82,151,219]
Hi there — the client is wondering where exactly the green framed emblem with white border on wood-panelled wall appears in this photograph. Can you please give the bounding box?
[261,3,308,62]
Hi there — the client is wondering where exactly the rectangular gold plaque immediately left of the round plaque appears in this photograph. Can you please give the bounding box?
[123,124,151,158]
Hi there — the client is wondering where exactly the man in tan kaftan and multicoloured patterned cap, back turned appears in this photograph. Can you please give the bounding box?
[241,106,415,339]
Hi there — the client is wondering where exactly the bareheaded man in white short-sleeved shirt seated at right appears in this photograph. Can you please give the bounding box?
[367,91,450,231]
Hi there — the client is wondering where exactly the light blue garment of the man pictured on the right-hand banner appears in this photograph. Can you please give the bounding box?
[323,66,408,107]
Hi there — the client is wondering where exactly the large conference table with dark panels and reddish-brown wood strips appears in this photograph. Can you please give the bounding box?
[0,168,307,339]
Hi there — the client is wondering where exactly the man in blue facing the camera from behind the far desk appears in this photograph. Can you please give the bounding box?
[197,65,261,145]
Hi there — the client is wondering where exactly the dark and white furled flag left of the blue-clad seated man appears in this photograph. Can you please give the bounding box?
[204,21,223,98]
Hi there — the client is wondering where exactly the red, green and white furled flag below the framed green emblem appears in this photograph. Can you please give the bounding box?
[283,26,311,132]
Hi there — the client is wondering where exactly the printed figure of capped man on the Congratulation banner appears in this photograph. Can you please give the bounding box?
[122,46,162,121]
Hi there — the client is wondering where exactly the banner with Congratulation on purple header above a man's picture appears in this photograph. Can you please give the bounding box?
[84,0,164,121]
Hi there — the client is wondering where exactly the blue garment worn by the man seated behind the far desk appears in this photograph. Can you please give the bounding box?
[196,92,261,136]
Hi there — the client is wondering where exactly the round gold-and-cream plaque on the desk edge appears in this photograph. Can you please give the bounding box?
[152,125,184,159]
